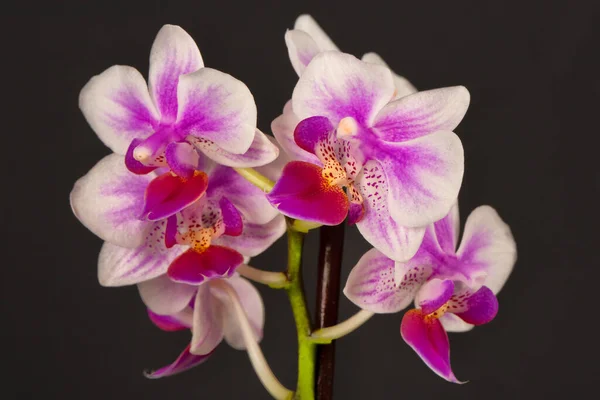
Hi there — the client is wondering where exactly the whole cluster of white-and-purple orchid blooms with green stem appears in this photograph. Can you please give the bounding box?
[71,15,516,399]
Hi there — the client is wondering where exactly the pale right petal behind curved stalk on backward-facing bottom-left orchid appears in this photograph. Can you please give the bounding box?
[211,274,265,350]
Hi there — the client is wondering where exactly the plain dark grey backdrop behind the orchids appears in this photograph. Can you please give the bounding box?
[5,0,600,399]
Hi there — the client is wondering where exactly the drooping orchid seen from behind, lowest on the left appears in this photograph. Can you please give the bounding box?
[138,274,265,378]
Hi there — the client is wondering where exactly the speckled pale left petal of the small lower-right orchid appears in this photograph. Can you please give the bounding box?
[344,249,431,314]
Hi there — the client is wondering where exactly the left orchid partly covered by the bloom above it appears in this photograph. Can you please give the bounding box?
[71,154,285,286]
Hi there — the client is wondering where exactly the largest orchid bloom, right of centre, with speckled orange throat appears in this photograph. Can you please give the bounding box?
[268,48,469,261]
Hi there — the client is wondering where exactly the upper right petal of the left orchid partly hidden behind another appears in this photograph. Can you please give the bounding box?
[206,165,279,224]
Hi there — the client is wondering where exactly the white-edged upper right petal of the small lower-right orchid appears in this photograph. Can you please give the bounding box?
[457,206,517,293]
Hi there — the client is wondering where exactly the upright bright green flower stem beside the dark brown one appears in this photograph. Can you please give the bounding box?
[286,228,316,400]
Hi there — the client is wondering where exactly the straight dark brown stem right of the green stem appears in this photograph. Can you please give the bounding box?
[316,223,344,400]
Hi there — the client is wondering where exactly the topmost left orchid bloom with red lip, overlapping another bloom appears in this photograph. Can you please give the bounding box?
[79,25,278,220]
